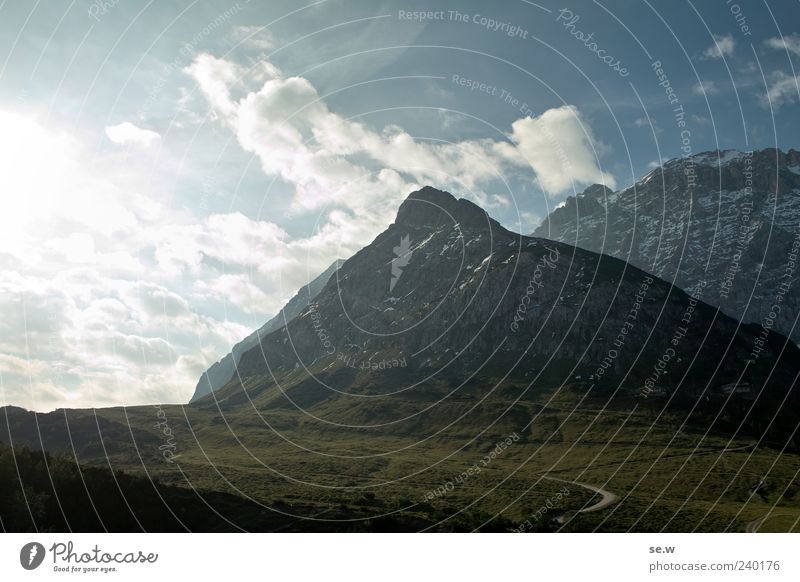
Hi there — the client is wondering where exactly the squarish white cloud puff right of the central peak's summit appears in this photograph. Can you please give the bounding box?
[511,105,616,195]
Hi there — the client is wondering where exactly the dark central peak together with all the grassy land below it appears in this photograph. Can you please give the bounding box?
[6,188,800,532]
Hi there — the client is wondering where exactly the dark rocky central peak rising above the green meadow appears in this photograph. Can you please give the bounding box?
[197,187,800,448]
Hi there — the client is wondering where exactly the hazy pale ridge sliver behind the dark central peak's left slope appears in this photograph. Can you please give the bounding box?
[189,259,342,402]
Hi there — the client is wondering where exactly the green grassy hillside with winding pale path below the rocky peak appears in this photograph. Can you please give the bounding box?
[0,385,800,531]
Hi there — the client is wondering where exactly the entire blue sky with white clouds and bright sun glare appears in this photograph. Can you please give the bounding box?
[0,0,800,411]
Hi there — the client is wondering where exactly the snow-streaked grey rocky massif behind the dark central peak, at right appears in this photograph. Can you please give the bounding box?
[533,149,800,343]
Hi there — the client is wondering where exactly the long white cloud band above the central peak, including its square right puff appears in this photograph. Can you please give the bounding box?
[185,55,613,210]
